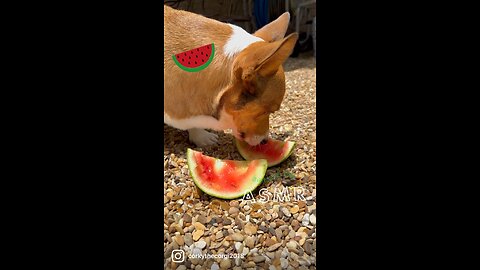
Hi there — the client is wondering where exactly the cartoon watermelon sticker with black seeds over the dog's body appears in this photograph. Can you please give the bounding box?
[172,43,215,72]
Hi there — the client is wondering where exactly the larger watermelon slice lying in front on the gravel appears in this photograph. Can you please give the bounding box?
[187,148,267,199]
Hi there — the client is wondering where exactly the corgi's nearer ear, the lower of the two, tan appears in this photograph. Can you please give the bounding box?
[233,33,298,94]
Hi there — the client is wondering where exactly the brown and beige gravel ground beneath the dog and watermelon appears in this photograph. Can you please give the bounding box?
[164,54,316,269]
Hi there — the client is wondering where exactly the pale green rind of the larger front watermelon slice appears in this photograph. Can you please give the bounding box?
[187,148,268,199]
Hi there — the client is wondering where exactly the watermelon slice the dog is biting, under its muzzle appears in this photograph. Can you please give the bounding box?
[235,139,295,167]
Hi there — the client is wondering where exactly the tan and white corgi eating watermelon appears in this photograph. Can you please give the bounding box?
[167,5,298,147]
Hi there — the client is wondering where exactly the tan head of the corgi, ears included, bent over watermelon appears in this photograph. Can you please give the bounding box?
[223,13,298,145]
